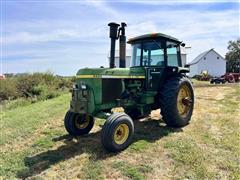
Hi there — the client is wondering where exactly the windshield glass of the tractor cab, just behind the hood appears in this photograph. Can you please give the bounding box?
[132,41,164,66]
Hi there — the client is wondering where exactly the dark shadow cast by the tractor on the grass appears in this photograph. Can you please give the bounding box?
[17,116,182,179]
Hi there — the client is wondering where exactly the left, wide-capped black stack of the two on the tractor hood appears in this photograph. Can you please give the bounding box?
[108,22,120,68]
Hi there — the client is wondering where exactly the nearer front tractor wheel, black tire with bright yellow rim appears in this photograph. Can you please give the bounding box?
[101,113,134,152]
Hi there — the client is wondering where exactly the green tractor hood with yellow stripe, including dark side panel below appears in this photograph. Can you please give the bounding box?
[75,67,145,111]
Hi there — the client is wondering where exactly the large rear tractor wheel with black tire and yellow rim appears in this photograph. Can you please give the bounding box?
[160,76,194,127]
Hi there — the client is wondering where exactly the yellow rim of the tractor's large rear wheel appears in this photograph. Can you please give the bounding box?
[177,85,192,118]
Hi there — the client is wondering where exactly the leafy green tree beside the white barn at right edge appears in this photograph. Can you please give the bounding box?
[225,39,240,73]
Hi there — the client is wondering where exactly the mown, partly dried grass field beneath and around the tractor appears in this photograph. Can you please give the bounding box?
[0,84,240,180]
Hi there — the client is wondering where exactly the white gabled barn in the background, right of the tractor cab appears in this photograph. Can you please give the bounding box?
[188,49,226,77]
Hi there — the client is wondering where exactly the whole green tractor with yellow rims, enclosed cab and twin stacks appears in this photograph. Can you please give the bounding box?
[64,23,194,152]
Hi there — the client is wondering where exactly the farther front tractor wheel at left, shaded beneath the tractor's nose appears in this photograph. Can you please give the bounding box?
[64,111,94,136]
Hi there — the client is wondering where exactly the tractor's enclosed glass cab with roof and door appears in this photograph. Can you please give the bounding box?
[128,33,188,91]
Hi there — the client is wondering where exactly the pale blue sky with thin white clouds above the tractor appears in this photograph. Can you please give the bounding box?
[0,0,240,76]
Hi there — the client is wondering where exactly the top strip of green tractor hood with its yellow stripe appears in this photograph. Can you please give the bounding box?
[76,67,145,79]
